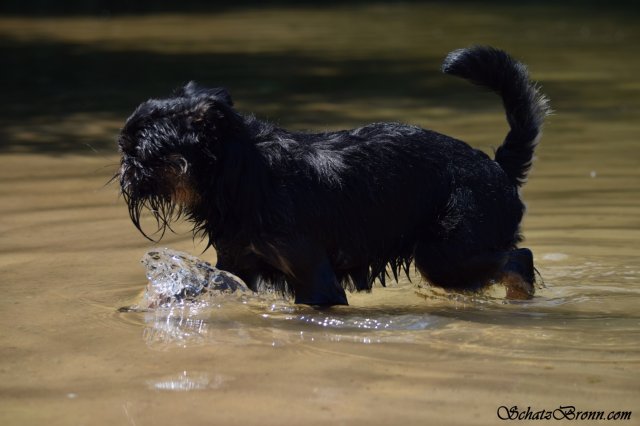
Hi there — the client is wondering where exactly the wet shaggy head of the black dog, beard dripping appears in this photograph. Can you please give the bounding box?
[116,82,240,238]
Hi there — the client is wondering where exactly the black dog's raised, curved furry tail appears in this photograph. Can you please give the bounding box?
[442,46,550,186]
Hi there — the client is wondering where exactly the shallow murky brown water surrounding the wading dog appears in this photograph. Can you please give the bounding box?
[0,4,640,425]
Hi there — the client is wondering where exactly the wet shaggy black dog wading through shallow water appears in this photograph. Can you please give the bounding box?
[118,47,548,305]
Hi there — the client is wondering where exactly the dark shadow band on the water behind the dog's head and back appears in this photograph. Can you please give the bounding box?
[0,39,456,154]
